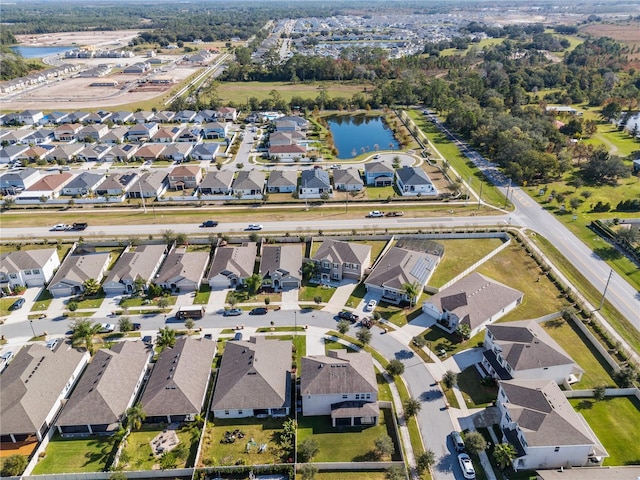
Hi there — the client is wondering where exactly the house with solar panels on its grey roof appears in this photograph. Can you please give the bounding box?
[364,246,441,305]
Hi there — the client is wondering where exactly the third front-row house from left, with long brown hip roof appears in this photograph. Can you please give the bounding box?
[140,336,216,423]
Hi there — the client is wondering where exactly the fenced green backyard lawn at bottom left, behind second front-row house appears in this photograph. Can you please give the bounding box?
[33,433,113,475]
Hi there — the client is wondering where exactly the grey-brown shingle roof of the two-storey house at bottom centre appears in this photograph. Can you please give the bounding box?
[300,350,378,395]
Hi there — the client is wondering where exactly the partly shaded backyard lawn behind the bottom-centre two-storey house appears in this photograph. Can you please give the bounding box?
[298,409,400,462]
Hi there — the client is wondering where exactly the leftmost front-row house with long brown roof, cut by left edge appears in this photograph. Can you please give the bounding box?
[0,342,89,443]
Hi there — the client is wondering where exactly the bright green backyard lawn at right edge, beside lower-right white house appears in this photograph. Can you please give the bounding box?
[569,397,640,465]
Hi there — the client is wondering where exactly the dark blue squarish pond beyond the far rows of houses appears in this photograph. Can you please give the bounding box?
[327,115,399,160]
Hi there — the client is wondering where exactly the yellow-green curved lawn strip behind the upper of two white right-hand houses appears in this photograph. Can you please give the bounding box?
[542,319,615,390]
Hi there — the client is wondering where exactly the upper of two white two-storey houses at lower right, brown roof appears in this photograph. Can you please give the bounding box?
[481,320,584,385]
